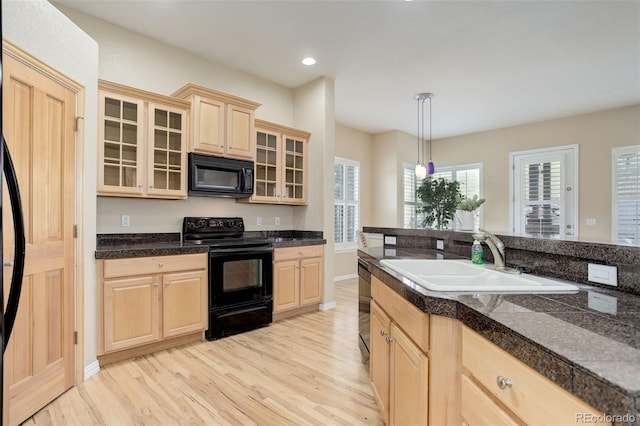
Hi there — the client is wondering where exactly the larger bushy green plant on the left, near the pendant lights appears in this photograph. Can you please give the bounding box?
[416,176,462,230]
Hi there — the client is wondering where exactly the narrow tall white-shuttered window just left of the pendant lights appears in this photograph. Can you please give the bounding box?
[333,158,360,248]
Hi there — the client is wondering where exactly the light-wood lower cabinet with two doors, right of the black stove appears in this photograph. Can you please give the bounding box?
[273,245,324,314]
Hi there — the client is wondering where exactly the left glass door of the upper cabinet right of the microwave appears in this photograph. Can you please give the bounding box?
[253,130,280,198]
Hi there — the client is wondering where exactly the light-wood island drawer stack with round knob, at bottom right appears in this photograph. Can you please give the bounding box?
[462,326,611,426]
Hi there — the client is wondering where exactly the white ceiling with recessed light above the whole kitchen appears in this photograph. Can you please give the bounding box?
[59,0,640,138]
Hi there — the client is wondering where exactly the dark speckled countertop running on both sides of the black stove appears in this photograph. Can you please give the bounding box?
[95,231,326,259]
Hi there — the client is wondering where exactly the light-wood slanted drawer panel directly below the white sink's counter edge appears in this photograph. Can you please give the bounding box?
[371,276,429,352]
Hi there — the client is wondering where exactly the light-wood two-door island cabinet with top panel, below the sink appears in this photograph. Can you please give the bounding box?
[369,277,429,425]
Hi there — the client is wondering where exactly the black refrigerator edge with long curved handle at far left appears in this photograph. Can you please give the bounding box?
[0,2,25,423]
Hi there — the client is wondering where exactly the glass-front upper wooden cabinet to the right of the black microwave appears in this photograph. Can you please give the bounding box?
[239,120,310,205]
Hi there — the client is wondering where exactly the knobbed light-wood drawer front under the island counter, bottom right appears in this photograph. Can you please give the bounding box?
[462,327,602,425]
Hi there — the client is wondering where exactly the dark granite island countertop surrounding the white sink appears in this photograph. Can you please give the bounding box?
[358,247,640,424]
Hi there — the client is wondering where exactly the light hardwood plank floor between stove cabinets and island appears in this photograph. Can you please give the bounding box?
[24,279,383,426]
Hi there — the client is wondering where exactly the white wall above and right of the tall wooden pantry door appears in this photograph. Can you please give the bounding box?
[2,0,98,376]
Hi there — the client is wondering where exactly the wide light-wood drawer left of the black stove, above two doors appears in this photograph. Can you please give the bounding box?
[104,253,207,278]
